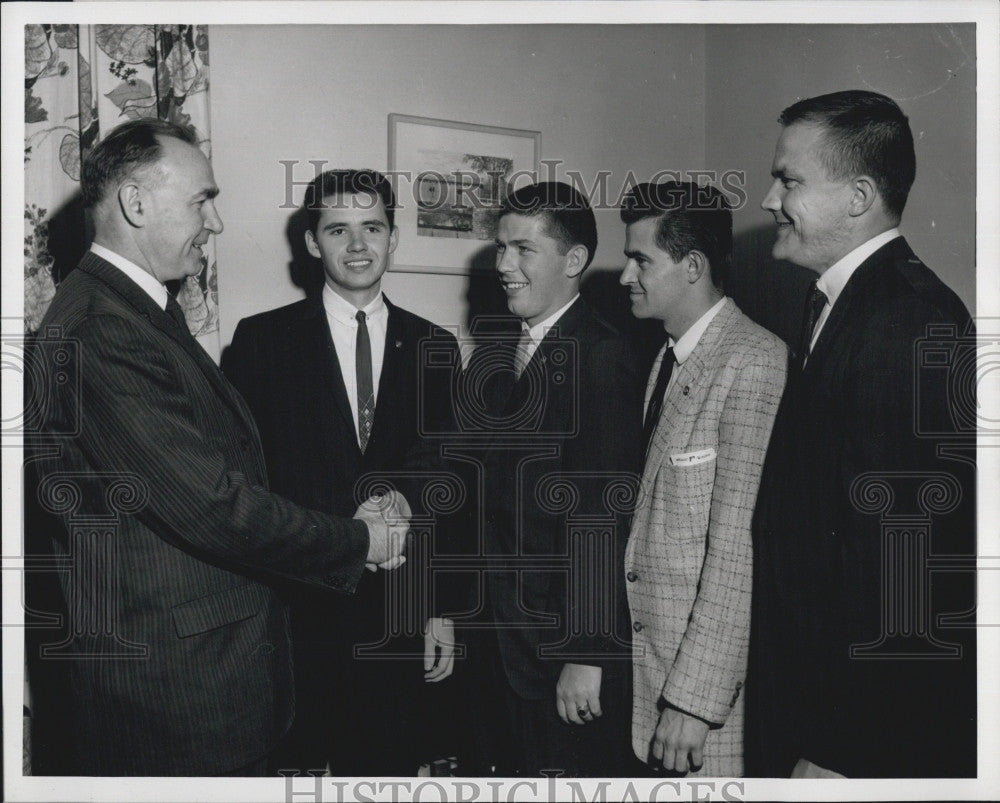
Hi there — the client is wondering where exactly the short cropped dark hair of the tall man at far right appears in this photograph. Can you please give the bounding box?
[778,89,917,218]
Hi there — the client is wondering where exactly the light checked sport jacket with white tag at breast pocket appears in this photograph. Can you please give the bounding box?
[625,299,786,776]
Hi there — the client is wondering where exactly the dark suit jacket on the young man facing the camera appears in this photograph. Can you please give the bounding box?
[223,298,460,638]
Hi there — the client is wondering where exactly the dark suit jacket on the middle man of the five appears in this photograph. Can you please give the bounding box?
[459,298,642,699]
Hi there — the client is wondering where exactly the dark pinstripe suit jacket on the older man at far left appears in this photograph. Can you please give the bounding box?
[29,253,368,776]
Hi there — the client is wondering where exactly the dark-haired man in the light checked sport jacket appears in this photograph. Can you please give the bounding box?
[621,182,786,776]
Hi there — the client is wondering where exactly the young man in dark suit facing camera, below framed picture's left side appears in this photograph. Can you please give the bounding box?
[224,170,459,776]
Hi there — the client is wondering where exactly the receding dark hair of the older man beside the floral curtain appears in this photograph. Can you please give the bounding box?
[80,117,198,209]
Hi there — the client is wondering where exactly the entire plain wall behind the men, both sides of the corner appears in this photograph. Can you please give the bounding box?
[211,25,976,346]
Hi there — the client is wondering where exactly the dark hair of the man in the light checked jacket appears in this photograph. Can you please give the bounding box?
[621,181,733,290]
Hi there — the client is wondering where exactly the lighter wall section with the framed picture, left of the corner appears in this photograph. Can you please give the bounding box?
[210,25,705,346]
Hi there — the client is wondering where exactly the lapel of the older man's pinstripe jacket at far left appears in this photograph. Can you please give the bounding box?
[79,251,255,429]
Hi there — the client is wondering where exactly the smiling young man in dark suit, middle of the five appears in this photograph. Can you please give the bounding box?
[458,182,642,776]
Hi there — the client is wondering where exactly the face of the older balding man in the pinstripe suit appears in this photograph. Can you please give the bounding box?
[136,137,222,282]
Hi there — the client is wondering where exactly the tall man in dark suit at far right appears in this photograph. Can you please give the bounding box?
[746,91,976,777]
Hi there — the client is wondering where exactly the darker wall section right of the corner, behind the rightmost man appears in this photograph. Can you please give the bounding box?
[705,24,976,310]
